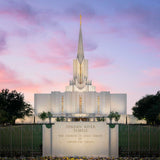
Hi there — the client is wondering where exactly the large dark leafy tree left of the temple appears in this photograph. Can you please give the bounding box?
[0,89,33,125]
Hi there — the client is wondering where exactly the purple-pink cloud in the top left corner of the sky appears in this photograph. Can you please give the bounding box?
[0,1,58,29]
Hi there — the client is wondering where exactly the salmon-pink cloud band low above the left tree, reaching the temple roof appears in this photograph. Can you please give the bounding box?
[0,63,67,104]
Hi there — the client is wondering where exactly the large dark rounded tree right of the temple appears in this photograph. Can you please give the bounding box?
[132,91,160,125]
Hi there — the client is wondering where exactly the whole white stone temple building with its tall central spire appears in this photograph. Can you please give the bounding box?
[34,15,127,121]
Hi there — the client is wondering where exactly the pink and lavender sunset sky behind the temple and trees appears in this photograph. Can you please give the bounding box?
[0,0,160,114]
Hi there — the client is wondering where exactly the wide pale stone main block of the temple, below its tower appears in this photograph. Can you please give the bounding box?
[34,91,127,114]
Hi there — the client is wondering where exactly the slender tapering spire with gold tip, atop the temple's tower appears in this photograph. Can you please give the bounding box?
[77,15,84,64]
